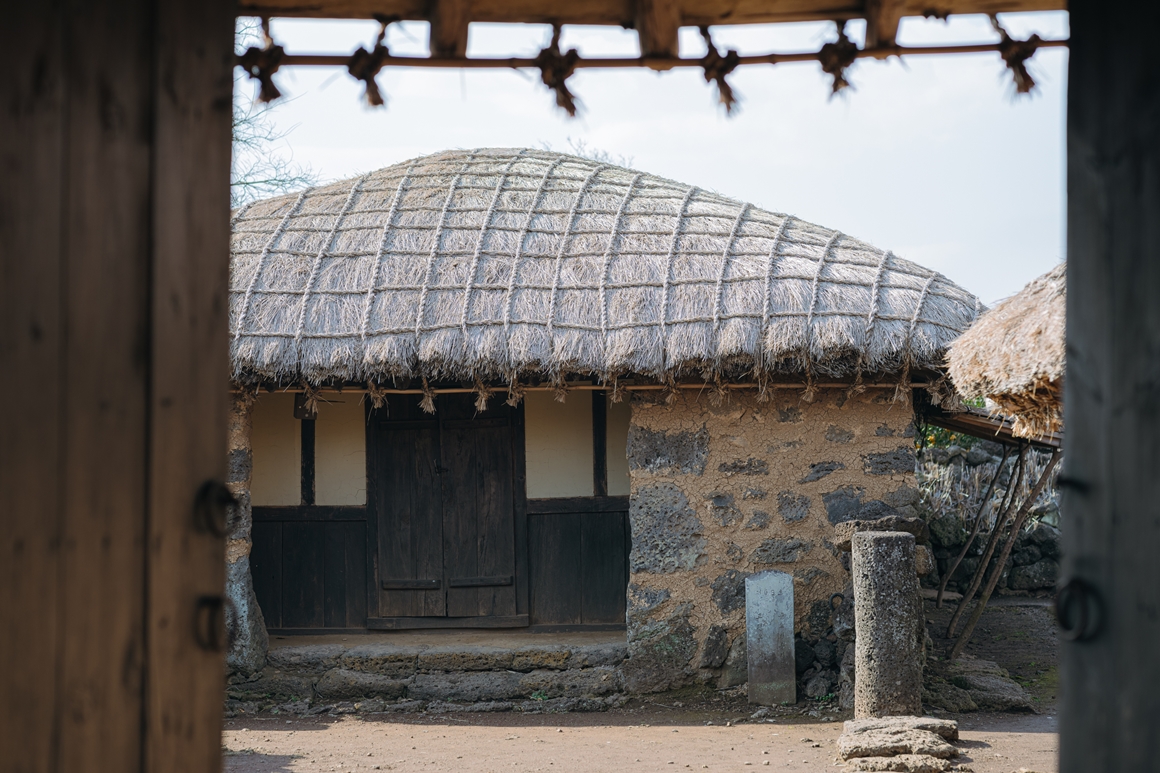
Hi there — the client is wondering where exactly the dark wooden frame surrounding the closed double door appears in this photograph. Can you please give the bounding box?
[365,394,530,630]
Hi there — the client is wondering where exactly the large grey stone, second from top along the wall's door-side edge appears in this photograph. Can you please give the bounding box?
[629,483,708,575]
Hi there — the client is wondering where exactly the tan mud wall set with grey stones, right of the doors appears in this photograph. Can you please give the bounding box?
[622,389,918,692]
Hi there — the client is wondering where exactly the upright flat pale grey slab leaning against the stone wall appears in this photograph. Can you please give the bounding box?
[745,571,797,706]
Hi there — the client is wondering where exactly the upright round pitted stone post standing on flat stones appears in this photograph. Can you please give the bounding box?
[851,532,925,720]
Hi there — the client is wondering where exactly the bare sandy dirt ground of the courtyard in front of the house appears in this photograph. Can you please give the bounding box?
[223,599,1057,773]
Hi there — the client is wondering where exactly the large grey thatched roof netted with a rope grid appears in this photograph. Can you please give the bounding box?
[230,149,980,384]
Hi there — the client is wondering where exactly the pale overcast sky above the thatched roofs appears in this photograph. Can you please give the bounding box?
[244,13,1067,304]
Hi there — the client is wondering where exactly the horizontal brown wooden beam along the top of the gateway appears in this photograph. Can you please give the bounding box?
[238,0,1067,24]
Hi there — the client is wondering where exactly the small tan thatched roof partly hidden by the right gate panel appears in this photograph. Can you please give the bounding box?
[947,263,1067,438]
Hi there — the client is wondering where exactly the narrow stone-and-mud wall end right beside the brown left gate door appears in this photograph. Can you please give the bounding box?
[225,392,270,676]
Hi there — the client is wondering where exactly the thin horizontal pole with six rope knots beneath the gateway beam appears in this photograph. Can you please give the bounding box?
[234,15,1068,117]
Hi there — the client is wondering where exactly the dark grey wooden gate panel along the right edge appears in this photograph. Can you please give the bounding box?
[1059,0,1160,773]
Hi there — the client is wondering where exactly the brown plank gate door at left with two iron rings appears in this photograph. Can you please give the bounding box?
[0,0,233,773]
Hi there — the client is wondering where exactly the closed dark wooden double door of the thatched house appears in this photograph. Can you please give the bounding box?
[367,395,528,628]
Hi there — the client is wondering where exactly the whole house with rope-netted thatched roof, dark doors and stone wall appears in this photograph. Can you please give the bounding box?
[230,150,979,692]
